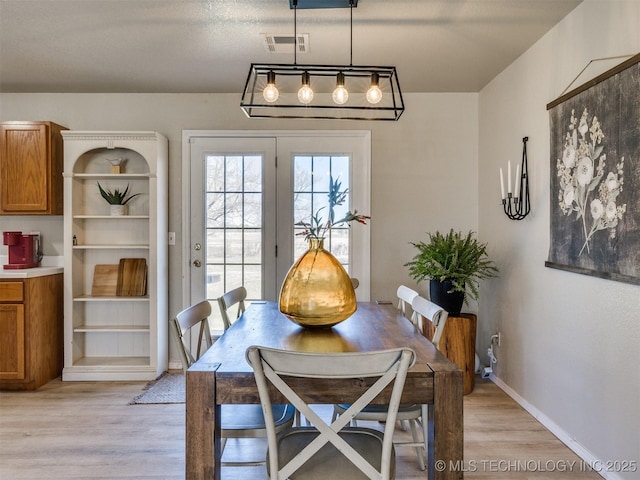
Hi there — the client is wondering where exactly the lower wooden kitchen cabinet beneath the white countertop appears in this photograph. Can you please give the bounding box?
[0,274,64,390]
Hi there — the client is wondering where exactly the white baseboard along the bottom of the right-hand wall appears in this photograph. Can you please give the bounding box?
[489,373,623,480]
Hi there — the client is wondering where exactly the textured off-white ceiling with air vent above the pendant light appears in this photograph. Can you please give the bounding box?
[0,0,582,93]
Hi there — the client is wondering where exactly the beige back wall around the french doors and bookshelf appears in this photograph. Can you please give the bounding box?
[0,93,478,359]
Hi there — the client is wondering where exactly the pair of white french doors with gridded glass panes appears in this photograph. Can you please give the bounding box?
[183,131,370,331]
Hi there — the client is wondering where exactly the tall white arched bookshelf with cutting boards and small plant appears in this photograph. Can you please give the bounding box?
[62,130,168,380]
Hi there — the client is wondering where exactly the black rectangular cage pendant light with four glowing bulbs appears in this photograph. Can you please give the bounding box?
[240,0,404,120]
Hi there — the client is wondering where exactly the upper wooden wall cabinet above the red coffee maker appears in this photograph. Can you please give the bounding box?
[0,122,67,215]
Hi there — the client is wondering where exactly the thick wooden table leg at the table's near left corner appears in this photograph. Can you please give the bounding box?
[185,364,220,480]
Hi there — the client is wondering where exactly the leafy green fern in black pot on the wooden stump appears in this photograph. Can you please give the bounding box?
[405,229,498,315]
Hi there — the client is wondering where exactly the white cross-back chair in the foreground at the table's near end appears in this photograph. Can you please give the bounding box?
[247,346,415,480]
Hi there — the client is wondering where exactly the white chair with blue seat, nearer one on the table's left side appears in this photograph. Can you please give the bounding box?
[170,300,295,466]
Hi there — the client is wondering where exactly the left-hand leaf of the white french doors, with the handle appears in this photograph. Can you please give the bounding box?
[190,137,277,332]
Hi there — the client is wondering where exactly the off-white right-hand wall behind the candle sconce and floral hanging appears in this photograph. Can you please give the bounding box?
[479,0,640,479]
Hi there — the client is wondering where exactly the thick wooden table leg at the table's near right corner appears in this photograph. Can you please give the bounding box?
[427,370,464,480]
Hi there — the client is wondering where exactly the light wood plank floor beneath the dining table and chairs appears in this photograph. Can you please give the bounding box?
[0,378,600,480]
